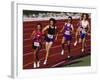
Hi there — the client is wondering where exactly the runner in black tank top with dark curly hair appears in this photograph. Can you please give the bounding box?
[42,18,58,65]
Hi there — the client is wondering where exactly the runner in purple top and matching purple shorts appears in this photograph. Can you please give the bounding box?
[60,16,74,58]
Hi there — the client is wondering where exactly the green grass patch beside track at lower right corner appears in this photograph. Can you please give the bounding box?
[64,55,91,67]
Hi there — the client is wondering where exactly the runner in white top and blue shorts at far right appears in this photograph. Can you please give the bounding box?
[74,13,90,52]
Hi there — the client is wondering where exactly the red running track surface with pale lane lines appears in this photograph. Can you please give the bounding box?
[23,20,91,69]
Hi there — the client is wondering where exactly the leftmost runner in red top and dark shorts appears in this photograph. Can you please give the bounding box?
[31,23,42,68]
